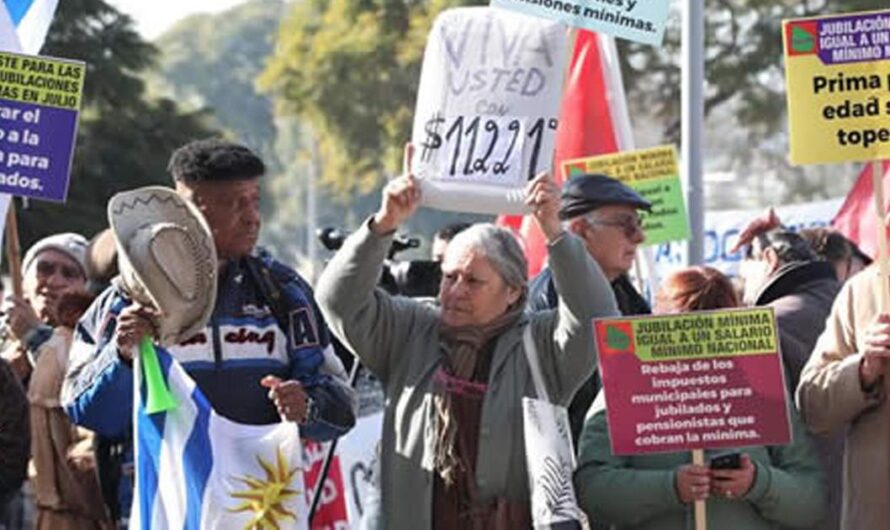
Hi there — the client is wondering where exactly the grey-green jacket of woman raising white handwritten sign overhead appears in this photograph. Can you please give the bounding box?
[316,223,618,530]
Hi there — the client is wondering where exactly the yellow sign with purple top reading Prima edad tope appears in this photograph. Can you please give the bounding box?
[782,10,890,164]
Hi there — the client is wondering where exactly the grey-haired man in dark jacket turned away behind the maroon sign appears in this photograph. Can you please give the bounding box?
[737,223,844,530]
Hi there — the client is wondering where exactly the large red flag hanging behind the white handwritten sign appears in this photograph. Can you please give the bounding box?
[497,30,627,276]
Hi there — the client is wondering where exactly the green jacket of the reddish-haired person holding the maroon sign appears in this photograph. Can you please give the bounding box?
[575,393,826,530]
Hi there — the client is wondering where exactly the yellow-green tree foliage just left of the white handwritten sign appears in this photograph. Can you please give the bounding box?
[260,0,481,196]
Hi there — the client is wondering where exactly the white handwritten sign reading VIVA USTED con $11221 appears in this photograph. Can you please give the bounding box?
[411,7,568,214]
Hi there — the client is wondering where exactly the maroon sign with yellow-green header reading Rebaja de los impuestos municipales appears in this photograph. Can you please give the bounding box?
[594,308,791,455]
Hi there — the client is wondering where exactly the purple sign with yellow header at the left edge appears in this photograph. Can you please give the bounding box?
[0,52,85,202]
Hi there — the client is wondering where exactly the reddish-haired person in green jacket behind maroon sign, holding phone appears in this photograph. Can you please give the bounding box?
[575,267,826,530]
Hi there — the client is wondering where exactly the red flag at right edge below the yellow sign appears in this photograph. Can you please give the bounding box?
[831,160,890,258]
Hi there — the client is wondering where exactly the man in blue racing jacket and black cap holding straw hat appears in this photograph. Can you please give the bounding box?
[63,139,355,440]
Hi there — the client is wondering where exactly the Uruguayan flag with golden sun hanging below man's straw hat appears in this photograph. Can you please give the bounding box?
[130,347,309,530]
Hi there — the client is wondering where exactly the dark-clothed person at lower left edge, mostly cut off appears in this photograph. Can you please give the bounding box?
[0,359,31,516]
